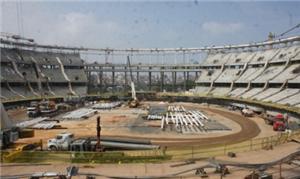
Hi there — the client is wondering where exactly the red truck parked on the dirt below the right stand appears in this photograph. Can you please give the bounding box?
[263,113,288,131]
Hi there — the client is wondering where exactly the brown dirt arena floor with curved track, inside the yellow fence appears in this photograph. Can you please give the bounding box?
[14,102,264,149]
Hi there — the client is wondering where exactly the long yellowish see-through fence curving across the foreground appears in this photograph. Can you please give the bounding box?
[1,131,300,163]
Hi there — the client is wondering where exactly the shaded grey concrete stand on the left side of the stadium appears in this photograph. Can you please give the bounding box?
[0,48,87,100]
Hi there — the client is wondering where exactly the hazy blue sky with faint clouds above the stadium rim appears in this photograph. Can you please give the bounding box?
[0,0,300,63]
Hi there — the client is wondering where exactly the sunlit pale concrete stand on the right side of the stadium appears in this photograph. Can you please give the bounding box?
[194,40,300,107]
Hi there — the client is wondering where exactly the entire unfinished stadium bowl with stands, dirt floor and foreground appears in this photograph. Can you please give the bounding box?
[0,2,300,178]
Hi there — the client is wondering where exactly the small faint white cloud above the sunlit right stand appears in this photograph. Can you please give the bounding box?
[201,22,243,34]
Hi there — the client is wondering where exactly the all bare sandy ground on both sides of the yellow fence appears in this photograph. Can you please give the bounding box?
[0,103,300,179]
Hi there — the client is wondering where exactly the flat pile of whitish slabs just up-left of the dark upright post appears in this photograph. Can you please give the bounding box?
[62,108,98,120]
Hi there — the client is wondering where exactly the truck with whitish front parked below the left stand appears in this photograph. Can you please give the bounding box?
[27,100,57,117]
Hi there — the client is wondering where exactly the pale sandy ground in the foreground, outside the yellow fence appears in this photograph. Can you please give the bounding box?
[0,142,300,179]
